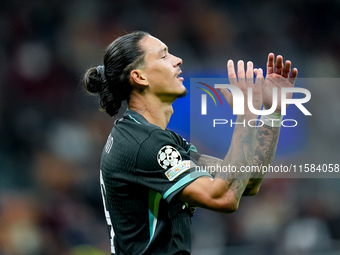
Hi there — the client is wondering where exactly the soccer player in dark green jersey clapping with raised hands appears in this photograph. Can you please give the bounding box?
[84,31,297,255]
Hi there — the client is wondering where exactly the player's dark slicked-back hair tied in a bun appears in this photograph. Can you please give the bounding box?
[84,31,148,116]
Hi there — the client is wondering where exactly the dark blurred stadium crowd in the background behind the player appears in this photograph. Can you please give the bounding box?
[0,0,340,255]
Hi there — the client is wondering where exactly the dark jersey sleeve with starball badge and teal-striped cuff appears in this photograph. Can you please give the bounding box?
[135,130,211,203]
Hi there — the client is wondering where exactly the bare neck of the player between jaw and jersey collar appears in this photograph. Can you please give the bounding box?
[129,91,174,129]
